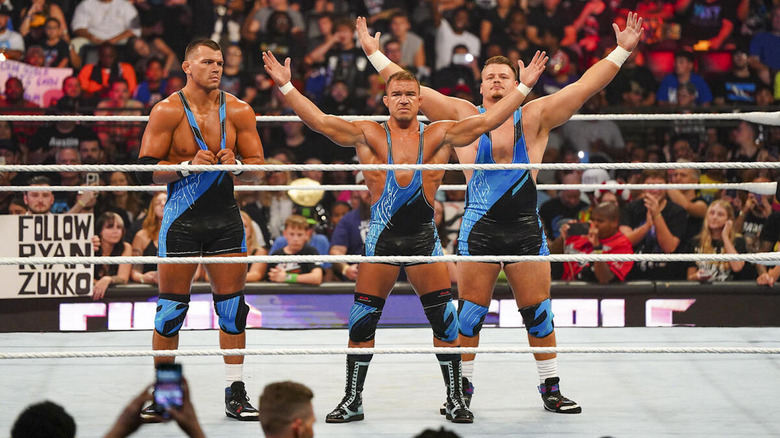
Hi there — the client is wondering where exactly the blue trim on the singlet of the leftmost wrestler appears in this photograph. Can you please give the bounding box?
[157,91,227,257]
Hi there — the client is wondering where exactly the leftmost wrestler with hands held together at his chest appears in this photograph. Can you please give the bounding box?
[138,39,263,421]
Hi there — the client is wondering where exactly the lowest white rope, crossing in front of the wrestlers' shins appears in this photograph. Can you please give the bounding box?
[0,347,780,359]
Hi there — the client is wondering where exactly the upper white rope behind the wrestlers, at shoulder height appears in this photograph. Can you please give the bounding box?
[0,111,780,126]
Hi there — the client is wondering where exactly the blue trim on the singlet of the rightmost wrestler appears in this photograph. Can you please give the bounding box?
[458,106,531,253]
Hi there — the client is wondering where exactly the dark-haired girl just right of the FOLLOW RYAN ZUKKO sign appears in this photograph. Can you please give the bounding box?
[92,212,133,300]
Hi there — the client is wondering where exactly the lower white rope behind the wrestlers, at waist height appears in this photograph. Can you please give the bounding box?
[9,183,777,195]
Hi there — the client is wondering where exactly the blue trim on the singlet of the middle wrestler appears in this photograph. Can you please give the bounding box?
[364,122,435,256]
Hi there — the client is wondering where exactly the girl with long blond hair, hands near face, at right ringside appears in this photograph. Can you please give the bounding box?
[683,200,755,282]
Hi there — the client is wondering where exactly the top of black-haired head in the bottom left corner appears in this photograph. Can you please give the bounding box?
[11,401,76,438]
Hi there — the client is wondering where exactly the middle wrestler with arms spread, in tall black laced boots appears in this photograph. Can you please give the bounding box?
[263,48,547,423]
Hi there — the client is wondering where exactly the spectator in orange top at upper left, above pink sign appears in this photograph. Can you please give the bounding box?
[79,41,138,97]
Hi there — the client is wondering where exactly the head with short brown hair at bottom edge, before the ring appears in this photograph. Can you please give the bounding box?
[258,381,314,437]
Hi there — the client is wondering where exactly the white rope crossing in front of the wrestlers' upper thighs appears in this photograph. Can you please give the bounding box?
[9,252,780,265]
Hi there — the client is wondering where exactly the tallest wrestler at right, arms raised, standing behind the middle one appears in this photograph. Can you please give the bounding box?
[358,13,642,413]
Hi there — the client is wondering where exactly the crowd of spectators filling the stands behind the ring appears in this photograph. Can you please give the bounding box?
[0,0,780,294]
